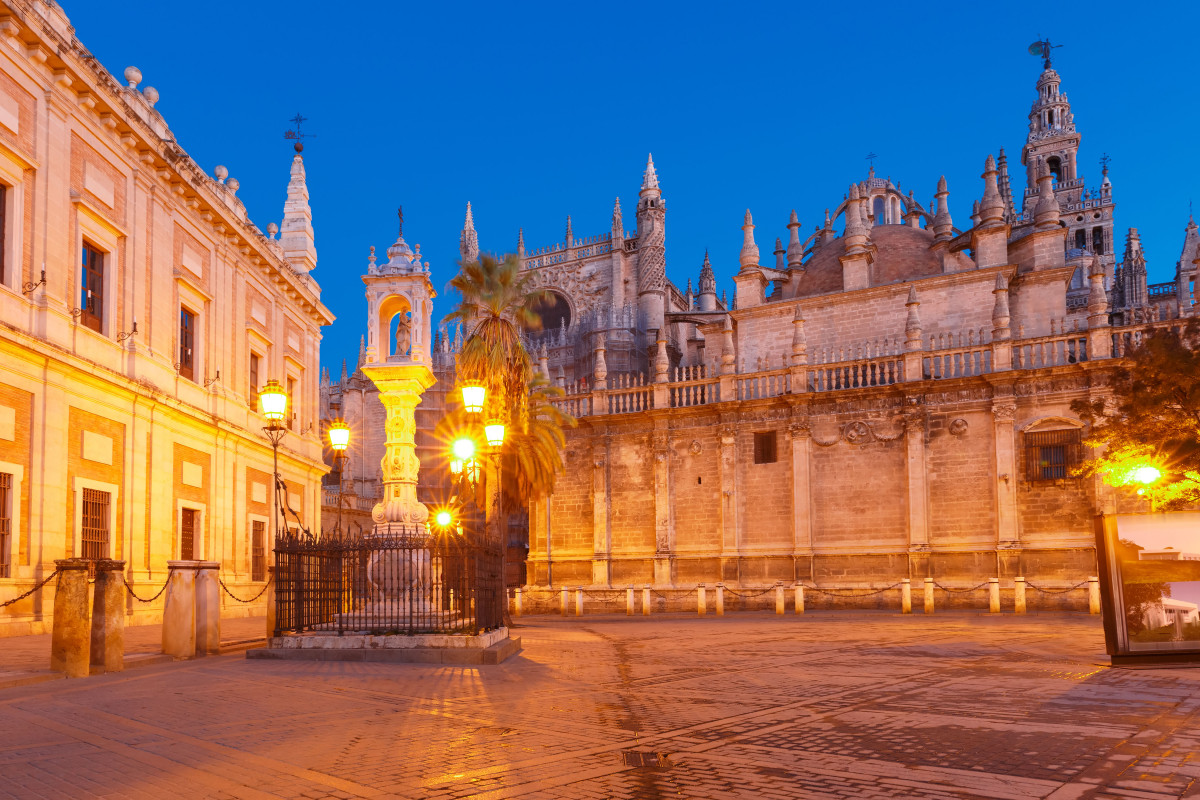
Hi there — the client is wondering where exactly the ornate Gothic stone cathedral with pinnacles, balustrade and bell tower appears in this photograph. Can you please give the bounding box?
[322,53,1200,597]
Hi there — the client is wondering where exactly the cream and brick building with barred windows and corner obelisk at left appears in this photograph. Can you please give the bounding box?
[0,0,332,636]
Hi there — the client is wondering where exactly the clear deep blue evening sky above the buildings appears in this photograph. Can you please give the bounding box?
[68,0,1200,378]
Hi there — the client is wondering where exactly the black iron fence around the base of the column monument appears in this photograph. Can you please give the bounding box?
[275,529,504,636]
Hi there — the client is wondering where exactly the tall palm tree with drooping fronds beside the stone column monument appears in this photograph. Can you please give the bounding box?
[436,254,575,621]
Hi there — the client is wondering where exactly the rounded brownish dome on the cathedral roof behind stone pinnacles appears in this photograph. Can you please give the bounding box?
[797,225,974,297]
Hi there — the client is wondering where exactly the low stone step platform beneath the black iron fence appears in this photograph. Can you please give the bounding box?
[246,627,521,664]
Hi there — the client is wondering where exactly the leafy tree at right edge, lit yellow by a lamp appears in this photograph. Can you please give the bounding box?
[1070,319,1200,511]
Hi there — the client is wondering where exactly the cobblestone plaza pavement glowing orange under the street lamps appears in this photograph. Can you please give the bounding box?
[0,612,1200,800]
